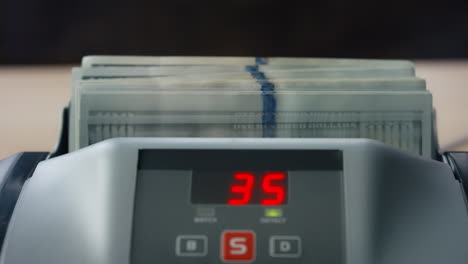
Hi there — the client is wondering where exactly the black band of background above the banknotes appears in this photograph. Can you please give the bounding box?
[0,0,468,64]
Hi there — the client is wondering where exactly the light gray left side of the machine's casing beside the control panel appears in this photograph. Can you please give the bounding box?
[0,143,137,264]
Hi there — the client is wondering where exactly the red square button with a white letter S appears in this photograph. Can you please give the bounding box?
[221,230,255,262]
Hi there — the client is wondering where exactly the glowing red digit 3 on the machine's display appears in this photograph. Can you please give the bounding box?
[228,172,255,205]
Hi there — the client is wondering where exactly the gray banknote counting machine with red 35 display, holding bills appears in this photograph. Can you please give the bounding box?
[0,56,468,264]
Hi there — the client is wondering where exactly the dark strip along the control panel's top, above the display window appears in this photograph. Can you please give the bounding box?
[138,149,343,170]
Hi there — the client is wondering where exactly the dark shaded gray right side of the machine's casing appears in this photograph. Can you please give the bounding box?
[373,147,468,264]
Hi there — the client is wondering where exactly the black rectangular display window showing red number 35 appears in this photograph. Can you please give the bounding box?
[191,170,288,206]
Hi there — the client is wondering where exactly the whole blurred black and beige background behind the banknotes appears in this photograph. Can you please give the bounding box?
[0,0,468,159]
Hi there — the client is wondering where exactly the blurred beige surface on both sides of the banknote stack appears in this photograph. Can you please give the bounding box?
[0,61,468,160]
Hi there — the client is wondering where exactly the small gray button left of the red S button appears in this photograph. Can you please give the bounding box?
[176,235,208,257]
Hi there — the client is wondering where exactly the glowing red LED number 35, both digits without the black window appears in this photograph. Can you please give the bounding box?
[227,171,287,206]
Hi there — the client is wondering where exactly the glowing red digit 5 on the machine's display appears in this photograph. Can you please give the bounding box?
[260,172,286,205]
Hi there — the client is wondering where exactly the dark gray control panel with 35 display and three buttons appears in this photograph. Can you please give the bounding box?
[132,149,344,264]
